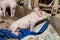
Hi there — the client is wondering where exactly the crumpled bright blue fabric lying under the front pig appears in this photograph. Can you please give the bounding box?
[0,20,49,40]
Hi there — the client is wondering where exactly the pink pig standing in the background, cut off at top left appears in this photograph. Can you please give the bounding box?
[0,0,17,17]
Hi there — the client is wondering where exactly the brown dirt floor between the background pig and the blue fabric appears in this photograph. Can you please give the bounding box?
[0,16,18,29]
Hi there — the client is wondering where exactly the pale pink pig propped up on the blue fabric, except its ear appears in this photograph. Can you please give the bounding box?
[9,11,51,35]
